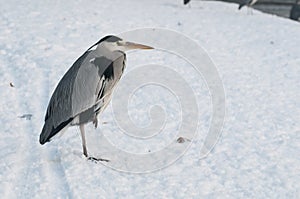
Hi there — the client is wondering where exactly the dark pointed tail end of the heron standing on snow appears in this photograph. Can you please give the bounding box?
[40,118,73,144]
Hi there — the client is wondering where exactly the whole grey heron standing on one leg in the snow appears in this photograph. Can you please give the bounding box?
[39,35,153,159]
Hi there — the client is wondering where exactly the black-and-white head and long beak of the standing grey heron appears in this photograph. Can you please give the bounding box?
[99,35,153,52]
